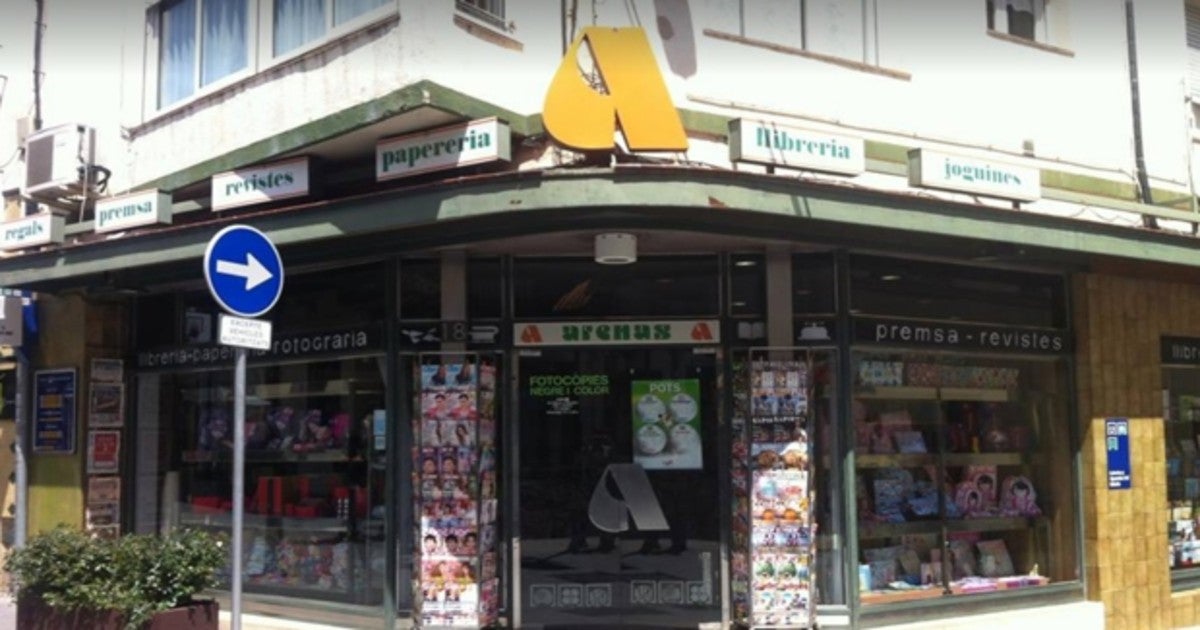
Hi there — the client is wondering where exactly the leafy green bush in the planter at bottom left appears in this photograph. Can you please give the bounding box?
[5,526,228,629]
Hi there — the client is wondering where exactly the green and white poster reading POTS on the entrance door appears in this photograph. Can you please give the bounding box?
[630,378,704,470]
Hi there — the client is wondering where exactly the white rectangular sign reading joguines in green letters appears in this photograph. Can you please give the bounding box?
[908,149,1042,202]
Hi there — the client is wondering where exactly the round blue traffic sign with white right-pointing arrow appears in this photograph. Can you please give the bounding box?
[204,226,283,317]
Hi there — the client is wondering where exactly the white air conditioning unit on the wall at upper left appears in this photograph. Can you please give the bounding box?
[22,124,96,200]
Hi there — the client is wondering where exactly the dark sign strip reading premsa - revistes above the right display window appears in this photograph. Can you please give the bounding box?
[854,318,1070,354]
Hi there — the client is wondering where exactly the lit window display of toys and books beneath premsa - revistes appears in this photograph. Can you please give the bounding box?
[851,353,1078,604]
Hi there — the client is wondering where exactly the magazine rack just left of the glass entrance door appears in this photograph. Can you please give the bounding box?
[413,353,499,628]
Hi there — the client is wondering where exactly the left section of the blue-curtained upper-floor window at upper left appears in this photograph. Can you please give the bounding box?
[158,0,250,107]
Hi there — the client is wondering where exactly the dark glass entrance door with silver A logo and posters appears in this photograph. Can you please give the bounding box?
[517,348,722,628]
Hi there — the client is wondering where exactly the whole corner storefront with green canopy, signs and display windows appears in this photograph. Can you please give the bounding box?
[11,2,1200,629]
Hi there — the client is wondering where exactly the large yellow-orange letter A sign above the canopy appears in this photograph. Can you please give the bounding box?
[541,26,688,151]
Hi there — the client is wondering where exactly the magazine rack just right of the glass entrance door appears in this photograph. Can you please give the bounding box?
[730,348,816,628]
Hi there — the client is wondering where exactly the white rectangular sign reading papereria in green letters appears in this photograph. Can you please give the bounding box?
[376,118,512,181]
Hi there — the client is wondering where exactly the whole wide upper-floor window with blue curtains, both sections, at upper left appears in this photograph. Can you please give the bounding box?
[150,0,393,108]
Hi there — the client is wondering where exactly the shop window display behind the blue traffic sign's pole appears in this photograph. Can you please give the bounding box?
[161,358,385,604]
